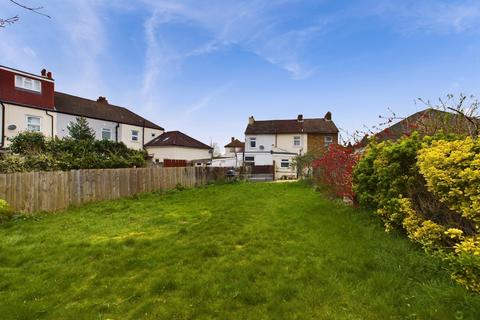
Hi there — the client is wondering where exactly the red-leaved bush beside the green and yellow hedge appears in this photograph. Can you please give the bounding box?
[312,144,358,200]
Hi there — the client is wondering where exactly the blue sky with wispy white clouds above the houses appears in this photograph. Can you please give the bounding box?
[0,0,480,146]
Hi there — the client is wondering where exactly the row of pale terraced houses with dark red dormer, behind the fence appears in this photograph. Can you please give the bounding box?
[0,66,164,149]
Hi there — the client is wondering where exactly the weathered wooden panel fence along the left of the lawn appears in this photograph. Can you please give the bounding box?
[0,167,224,213]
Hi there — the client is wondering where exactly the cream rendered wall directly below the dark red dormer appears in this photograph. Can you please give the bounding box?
[1,103,57,147]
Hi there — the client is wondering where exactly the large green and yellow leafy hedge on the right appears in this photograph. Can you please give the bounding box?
[353,134,480,292]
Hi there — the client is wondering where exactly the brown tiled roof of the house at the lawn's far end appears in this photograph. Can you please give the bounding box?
[245,118,338,134]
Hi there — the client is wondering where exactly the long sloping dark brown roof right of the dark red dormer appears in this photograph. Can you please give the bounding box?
[55,92,164,130]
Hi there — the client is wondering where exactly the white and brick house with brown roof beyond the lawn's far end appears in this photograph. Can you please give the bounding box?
[244,112,338,179]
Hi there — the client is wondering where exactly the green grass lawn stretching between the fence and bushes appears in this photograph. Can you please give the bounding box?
[0,183,480,319]
